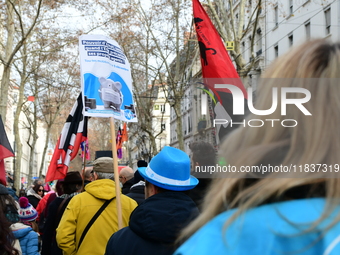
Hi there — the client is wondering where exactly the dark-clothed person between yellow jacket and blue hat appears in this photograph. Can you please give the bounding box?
[126,160,148,205]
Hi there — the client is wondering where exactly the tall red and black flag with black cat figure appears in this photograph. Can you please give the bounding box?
[193,0,247,142]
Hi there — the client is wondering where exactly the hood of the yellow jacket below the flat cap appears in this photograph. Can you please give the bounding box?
[85,179,116,200]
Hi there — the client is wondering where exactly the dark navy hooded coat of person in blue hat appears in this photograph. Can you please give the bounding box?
[105,191,198,255]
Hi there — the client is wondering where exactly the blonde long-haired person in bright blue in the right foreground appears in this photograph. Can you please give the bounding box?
[175,39,340,255]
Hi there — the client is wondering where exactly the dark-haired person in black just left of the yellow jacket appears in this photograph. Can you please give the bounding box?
[41,172,83,255]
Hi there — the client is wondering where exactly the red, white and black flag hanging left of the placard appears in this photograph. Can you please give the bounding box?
[45,93,87,182]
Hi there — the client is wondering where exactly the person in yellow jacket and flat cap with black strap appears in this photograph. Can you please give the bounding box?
[56,157,137,255]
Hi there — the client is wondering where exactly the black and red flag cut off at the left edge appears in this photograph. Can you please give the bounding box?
[0,115,14,185]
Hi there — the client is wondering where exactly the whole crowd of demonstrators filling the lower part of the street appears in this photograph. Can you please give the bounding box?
[5,40,340,255]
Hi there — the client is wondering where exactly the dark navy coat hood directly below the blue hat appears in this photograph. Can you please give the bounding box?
[129,191,198,243]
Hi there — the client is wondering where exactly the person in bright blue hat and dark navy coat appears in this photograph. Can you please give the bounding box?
[105,146,198,255]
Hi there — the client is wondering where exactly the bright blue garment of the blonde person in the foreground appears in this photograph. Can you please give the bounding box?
[174,198,340,255]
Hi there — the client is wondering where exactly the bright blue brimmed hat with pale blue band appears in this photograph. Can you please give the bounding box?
[138,146,198,191]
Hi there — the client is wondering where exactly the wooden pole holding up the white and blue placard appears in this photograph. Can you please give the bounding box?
[110,117,123,229]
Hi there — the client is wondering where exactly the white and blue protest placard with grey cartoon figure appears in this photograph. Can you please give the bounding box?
[79,35,137,122]
